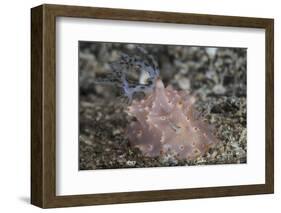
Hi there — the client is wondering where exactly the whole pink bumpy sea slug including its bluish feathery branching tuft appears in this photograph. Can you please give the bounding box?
[96,46,218,160]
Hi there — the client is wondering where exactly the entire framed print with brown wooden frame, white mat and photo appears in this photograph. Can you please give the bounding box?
[31,5,274,208]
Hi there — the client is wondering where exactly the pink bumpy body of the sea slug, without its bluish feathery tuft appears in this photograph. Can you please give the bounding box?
[127,79,218,160]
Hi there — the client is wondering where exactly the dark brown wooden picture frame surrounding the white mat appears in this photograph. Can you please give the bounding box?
[31,5,274,208]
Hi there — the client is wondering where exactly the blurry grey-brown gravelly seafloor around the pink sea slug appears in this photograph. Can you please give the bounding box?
[79,42,247,170]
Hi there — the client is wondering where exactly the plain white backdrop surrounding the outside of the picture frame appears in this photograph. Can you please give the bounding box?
[0,0,281,213]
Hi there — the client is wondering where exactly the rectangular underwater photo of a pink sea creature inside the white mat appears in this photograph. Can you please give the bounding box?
[77,41,247,170]
